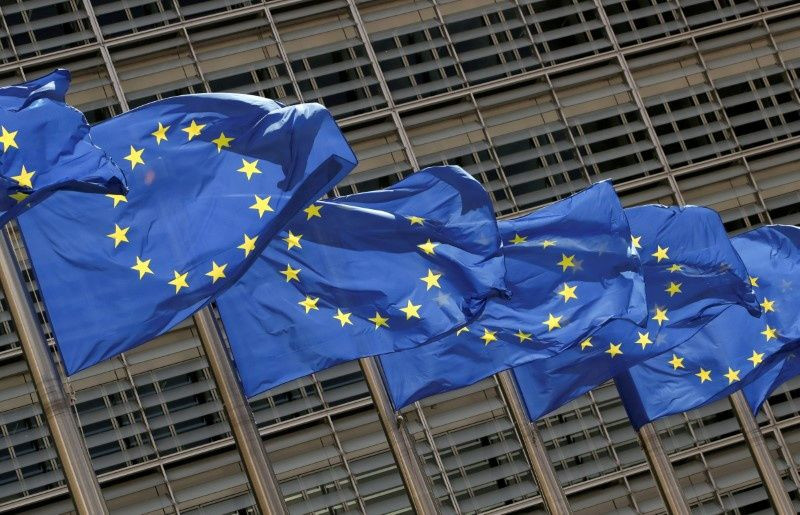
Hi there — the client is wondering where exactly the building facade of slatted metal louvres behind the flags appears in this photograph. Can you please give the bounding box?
[0,0,800,514]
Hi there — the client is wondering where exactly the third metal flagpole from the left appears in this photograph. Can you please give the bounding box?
[358,358,441,515]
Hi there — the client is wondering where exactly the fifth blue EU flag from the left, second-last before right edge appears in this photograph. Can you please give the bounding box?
[514,206,759,420]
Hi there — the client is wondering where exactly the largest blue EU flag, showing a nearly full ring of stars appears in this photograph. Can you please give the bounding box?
[20,94,356,374]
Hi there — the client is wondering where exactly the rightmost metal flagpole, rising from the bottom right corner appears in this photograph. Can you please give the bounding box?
[728,390,796,515]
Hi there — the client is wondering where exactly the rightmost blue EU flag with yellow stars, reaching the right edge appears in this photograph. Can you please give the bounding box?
[615,226,800,428]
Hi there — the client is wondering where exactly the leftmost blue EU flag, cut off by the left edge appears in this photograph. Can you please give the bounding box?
[0,70,126,222]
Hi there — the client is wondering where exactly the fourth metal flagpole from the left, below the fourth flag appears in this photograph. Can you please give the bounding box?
[495,370,570,515]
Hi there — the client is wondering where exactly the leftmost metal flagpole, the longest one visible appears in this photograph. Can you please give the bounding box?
[0,230,108,515]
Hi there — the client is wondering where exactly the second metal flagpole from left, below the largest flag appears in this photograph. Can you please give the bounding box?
[193,307,288,514]
